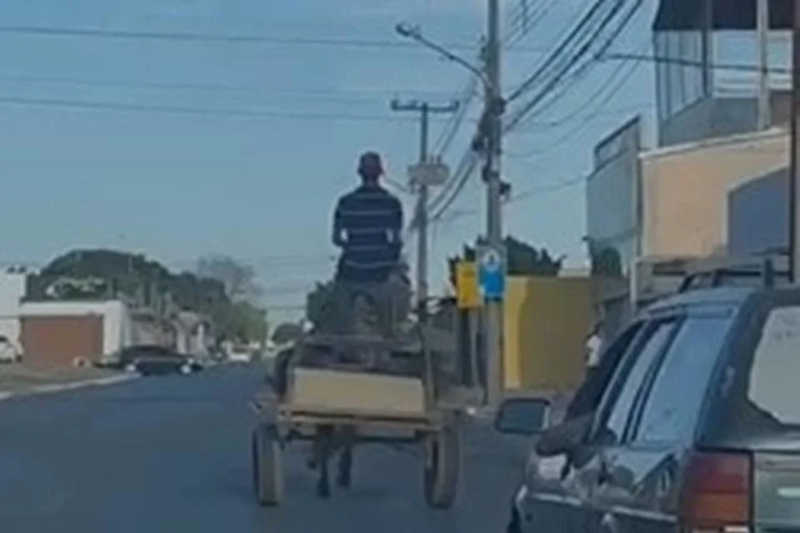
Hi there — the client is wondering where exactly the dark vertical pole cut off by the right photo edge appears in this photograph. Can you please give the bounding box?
[789,0,800,282]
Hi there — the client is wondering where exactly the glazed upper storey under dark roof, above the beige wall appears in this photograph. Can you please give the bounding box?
[653,0,793,146]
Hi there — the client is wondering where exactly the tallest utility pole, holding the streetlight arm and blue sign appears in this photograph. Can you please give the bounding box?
[483,0,506,407]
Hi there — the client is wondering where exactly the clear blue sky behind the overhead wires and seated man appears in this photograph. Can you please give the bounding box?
[0,0,655,320]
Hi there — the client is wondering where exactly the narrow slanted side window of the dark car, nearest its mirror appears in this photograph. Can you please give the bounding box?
[599,321,676,444]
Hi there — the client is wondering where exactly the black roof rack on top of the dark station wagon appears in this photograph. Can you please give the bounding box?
[678,257,789,293]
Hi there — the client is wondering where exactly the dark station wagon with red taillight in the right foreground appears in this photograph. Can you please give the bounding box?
[495,288,800,533]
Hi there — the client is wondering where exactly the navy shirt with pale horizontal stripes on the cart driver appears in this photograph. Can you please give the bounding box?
[333,185,403,282]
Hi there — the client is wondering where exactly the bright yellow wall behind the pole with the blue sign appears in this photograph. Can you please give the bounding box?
[503,277,594,390]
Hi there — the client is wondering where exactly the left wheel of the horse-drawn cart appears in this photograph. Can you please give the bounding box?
[252,424,283,505]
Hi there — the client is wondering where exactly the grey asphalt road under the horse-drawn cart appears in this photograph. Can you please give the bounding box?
[0,367,527,533]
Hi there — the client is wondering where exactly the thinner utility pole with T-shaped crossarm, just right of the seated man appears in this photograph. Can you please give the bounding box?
[391,100,459,320]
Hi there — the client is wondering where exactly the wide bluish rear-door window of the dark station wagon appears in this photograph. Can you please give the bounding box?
[635,317,731,442]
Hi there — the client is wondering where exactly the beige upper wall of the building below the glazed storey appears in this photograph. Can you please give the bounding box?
[642,132,789,256]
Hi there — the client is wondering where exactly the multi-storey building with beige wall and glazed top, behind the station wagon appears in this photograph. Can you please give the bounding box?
[586,0,793,326]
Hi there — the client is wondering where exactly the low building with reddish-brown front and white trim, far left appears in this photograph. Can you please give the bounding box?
[20,300,132,368]
